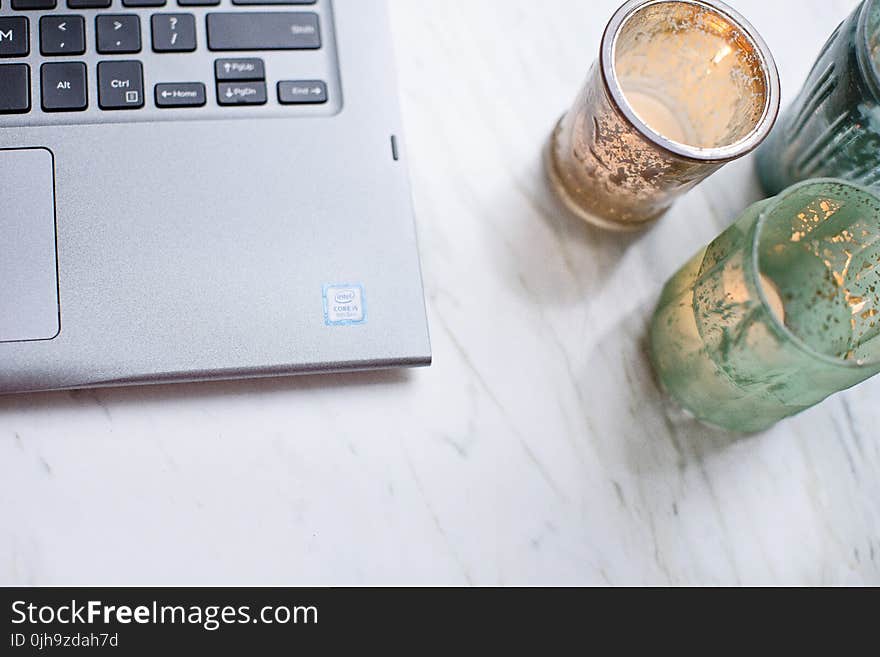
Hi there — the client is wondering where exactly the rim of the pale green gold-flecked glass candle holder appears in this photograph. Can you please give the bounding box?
[744,178,880,371]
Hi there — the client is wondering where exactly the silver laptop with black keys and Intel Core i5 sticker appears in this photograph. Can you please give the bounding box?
[0,0,431,392]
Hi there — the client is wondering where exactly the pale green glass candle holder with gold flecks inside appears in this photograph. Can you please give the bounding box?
[651,179,880,433]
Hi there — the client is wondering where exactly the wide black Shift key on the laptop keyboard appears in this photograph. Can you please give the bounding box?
[208,12,321,50]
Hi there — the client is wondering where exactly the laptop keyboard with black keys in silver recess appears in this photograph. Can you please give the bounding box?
[0,0,341,125]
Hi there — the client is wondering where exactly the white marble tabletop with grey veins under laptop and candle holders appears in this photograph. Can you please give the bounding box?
[0,0,880,585]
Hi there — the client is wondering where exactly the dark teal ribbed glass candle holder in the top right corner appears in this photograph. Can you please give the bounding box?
[757,0,880,195]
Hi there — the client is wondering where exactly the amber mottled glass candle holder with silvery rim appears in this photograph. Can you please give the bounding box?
[547,0,780,230]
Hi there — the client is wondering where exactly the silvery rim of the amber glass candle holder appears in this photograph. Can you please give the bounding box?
[599,0,781,162]
